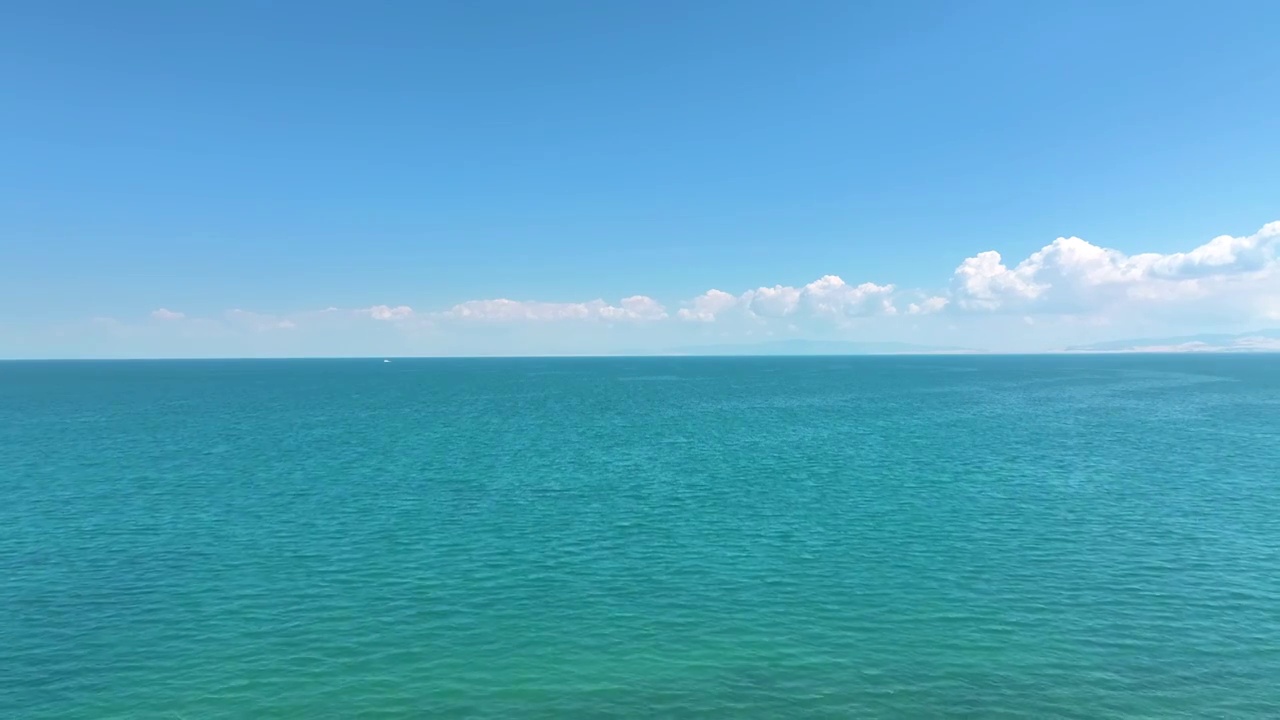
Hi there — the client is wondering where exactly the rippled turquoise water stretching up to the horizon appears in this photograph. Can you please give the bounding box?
[0,356,1280,720]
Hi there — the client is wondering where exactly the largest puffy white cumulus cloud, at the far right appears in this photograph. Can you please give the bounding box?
[951,222,1280,313]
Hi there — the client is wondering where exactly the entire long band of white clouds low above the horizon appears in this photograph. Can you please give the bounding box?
[57,220,1280,350]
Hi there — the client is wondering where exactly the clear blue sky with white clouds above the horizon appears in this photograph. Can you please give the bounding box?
[0,0,1280,357]
